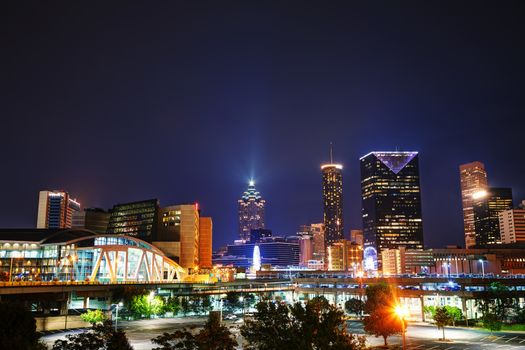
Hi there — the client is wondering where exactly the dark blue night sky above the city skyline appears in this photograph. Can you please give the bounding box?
[0,1,525,248]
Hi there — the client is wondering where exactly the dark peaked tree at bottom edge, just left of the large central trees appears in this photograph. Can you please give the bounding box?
[151,313,237,350]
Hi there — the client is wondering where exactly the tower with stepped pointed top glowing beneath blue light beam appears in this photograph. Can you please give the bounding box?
[239,180,266,242]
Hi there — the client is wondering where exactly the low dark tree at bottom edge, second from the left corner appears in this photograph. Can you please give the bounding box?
[52,321,133,350]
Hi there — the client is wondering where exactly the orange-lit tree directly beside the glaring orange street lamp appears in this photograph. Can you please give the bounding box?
[363,283,403,346]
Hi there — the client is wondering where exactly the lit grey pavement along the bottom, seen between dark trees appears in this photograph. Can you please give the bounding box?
[43,317,525,350]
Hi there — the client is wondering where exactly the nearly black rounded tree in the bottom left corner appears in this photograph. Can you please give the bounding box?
[0,302,42,350]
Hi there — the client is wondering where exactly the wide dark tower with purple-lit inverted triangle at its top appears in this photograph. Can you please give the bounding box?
[360,151,423,257]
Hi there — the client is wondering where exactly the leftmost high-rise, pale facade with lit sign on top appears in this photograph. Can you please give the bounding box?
[36,191,80,228]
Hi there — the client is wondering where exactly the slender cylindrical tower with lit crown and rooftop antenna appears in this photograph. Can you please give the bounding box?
[321,148,344,247]
